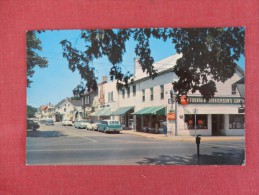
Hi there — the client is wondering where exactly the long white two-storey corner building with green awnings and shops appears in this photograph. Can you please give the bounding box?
[92,54,245,135]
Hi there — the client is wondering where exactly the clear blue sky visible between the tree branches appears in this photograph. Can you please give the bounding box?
[27,30,245,108]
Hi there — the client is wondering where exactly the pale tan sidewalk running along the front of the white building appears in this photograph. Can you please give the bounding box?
[120,130,245,142]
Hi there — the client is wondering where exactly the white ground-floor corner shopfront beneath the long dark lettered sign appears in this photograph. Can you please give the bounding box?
[177,97,245,136]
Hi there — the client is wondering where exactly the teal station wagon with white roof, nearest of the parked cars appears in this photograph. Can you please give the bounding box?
[98,120,122,133]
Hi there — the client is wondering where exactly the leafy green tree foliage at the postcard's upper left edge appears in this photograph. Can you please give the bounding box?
[26,31,48,87]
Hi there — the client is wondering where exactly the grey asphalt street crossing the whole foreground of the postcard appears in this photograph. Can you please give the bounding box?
[26,123,245,165]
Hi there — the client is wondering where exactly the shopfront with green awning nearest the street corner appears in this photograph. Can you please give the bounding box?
[133,106,166,133]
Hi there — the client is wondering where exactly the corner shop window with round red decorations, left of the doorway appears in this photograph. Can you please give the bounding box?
[184,114,208,130]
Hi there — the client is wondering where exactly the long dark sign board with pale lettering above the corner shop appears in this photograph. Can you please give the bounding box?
[188,96,244,104]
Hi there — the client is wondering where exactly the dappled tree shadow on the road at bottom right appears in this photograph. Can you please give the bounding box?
[136,152,244,165]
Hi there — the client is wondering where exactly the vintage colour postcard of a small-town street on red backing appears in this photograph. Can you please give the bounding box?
[26,27,245,165]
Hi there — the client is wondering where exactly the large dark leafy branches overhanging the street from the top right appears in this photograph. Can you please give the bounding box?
[61,27,245,100]
